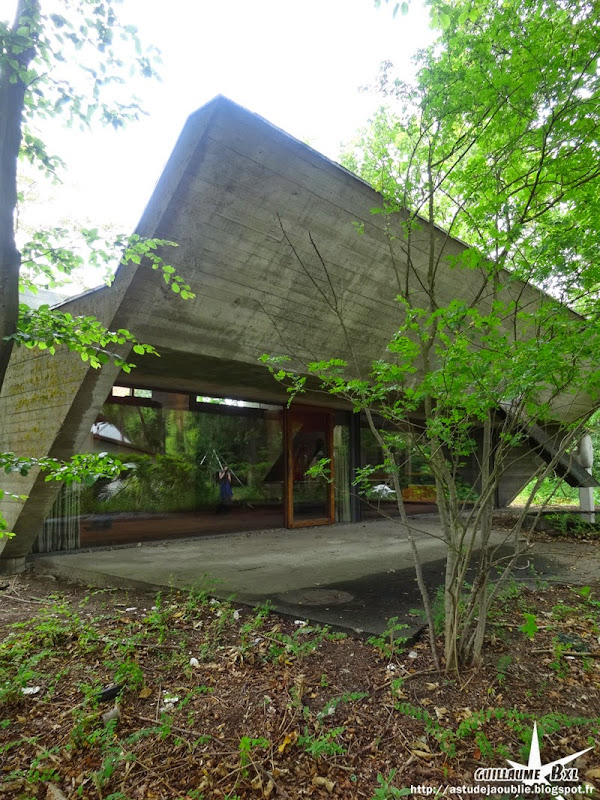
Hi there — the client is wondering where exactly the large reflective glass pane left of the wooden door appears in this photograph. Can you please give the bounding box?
[40,390,285,550]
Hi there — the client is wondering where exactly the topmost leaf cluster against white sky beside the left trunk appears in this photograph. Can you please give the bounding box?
[0,0,157,136]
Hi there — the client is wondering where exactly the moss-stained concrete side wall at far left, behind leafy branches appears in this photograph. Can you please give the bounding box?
[0,273,132,572]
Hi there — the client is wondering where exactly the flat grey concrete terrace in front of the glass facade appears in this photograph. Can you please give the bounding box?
[31,515,588,636]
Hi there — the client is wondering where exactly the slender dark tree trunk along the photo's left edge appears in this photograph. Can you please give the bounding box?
[0,0,40,389]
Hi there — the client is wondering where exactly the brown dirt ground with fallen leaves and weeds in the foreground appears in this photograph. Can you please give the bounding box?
[0,576,600,800]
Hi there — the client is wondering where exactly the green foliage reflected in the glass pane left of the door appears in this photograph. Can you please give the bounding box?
[81,403,282,514]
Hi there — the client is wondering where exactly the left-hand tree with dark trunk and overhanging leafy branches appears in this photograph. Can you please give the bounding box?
[0,0,192,535]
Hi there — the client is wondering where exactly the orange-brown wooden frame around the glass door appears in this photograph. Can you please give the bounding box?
[283,405,335,528]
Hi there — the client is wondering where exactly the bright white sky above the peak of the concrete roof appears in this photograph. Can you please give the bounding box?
[0,0,432,288]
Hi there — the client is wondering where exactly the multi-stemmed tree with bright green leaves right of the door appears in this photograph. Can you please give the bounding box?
[267,0,600,671]
